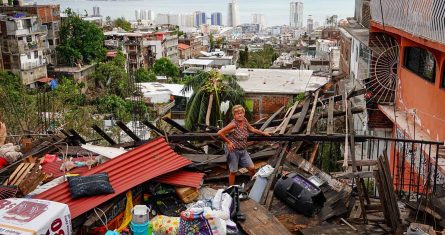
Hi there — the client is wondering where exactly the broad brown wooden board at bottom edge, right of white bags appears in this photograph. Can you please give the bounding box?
[239,199,291,235]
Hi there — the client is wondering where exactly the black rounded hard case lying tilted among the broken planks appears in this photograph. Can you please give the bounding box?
[274,173,326,216]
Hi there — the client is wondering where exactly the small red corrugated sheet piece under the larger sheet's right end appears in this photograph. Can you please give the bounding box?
[154,171,204,188]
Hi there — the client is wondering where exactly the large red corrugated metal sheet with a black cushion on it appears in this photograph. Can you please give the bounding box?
[35,138,191,218]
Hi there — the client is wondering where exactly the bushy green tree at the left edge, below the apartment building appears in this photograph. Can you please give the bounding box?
[0,71,37,134]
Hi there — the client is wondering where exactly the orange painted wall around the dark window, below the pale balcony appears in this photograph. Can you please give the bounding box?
[371,22,445,141]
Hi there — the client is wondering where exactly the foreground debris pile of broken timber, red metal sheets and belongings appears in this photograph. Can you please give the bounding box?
[0,77,443,235]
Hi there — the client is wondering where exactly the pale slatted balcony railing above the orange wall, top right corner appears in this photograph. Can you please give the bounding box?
[371,0,445,44]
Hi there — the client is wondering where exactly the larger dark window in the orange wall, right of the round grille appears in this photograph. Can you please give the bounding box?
[404,47,436,83]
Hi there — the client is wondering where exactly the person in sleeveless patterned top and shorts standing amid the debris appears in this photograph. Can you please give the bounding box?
[218,105,269,185]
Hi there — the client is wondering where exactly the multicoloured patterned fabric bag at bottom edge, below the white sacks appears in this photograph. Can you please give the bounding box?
[178,208,213,235]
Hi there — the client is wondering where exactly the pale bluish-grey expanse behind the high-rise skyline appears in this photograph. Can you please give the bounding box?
[34,0,355,26]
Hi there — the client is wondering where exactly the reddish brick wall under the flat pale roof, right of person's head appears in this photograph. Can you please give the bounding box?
[246,94,293,122]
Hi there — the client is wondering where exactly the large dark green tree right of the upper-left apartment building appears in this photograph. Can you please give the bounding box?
[56,8,106,66]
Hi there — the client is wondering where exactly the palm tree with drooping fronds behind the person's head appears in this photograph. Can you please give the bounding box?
[182,70,250,130]
